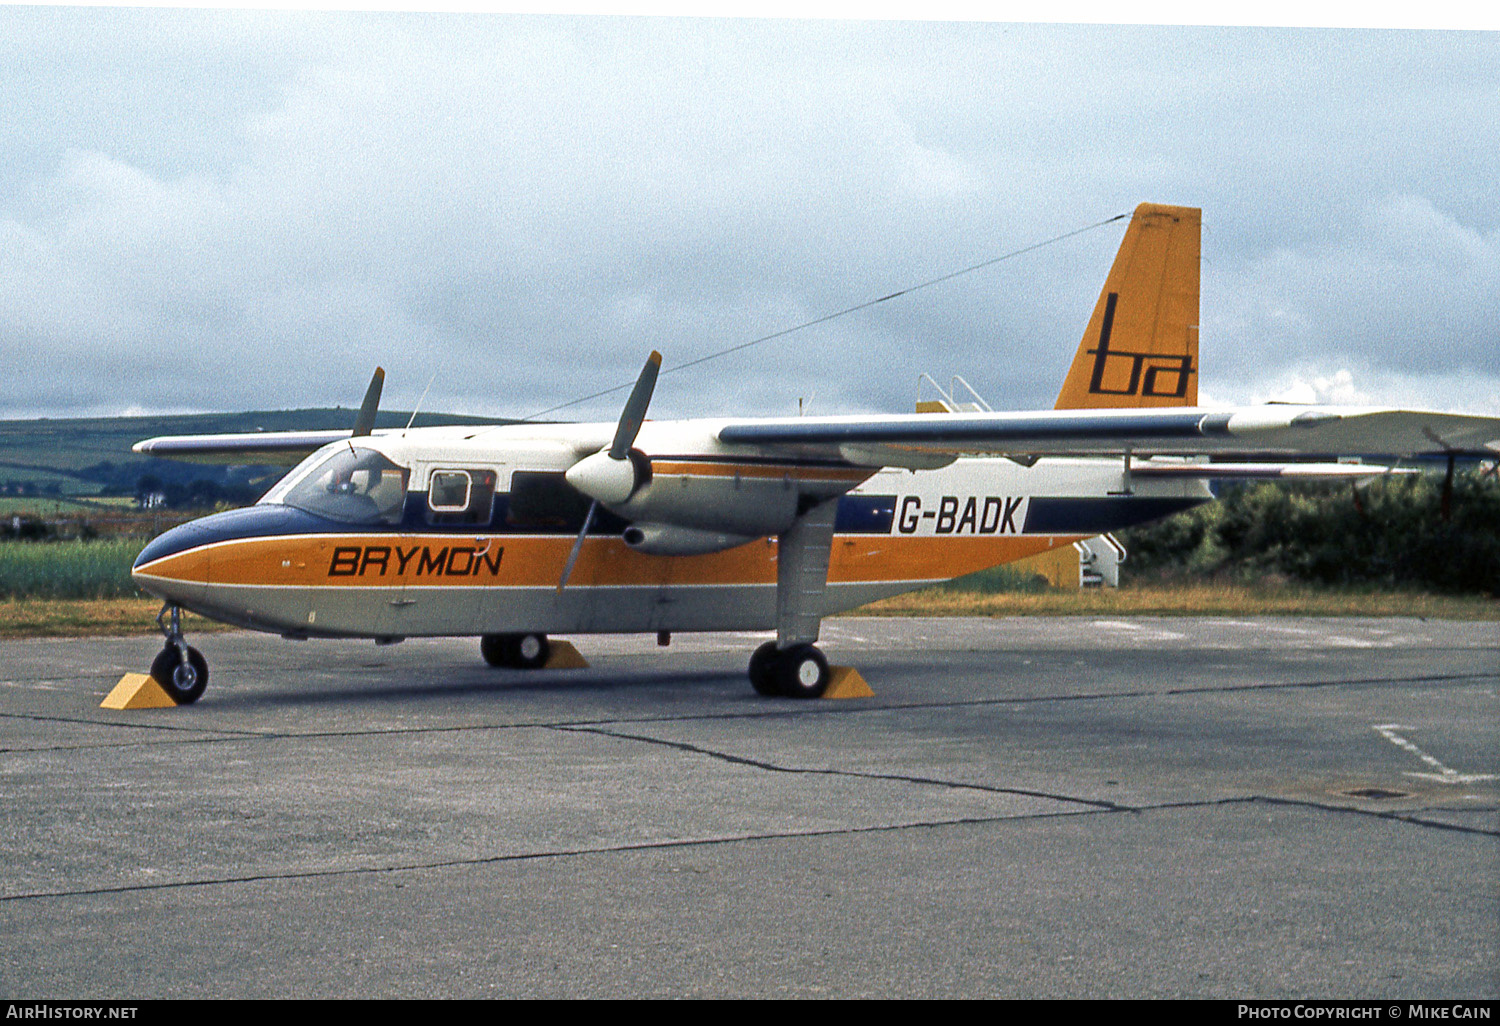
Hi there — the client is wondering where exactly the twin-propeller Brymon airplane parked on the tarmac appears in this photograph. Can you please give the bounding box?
[132,204,1500,705]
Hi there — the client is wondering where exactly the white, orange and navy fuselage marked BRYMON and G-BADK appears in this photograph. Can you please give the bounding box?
[126,422,1212,638]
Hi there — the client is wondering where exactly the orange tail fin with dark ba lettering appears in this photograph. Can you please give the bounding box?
[1056,203,1203,410]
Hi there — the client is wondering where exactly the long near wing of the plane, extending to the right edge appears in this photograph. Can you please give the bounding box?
[719,404,1500,467]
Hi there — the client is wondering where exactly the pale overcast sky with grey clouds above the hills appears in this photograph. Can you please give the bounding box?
[0,8,1500,419]
